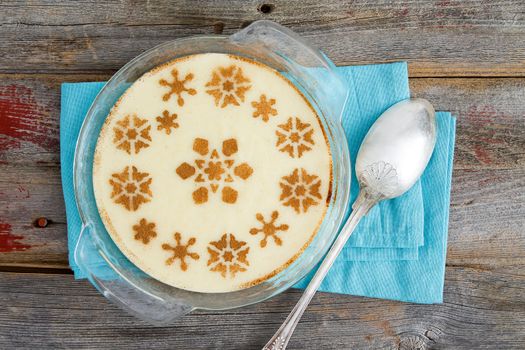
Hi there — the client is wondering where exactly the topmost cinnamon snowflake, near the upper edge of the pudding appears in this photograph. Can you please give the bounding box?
[206,65,251,108]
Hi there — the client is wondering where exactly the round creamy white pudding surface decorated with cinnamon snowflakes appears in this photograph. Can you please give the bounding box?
[93,53,332,292]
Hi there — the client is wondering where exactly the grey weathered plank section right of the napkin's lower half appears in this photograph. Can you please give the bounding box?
[447,169,525,267]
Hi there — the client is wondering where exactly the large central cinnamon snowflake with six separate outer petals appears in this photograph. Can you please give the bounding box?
[176,138,253,204]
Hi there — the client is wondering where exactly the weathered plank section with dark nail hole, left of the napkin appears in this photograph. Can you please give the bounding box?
[0,165,68,267]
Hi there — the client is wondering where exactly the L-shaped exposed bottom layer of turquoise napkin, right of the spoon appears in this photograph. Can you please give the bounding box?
[296,112,456,304]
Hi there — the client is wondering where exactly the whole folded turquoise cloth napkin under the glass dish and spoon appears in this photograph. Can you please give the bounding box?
[60,63,455,303]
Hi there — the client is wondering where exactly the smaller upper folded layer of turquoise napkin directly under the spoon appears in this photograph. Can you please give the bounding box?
[338,62,424,261]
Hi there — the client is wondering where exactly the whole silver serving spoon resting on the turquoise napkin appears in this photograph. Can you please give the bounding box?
[263,99,436,350]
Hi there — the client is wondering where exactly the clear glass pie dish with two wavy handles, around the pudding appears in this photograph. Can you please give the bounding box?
[74,21,350,324]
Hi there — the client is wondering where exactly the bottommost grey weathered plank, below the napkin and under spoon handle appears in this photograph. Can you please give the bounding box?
[0,266,525,350]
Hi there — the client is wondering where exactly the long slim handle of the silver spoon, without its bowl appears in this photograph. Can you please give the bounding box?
[262,192,377,350]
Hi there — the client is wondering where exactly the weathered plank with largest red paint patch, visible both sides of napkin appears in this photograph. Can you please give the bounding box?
[0,74,525,169]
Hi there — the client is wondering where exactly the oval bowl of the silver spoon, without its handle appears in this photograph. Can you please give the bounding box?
[355,98,436,199]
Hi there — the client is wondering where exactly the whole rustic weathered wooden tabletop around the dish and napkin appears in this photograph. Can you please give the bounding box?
[0,0,525,349]
